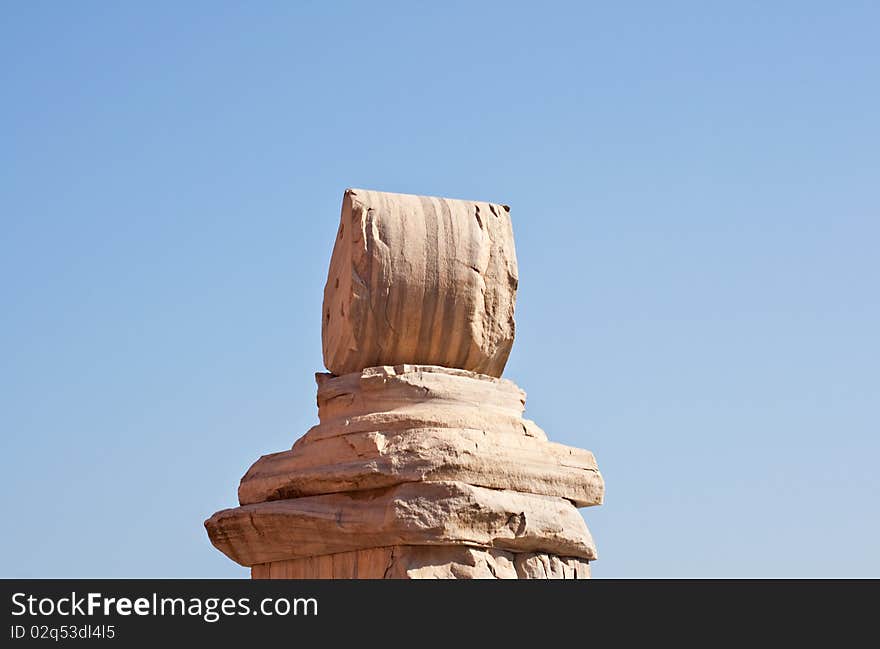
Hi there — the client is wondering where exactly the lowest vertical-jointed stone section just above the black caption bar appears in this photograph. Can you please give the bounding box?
[251,545,590,579]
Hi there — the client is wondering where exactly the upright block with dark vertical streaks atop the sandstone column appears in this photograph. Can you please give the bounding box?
[321,189,518,376]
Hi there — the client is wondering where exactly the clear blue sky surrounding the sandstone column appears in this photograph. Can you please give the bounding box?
[0,1,880,577]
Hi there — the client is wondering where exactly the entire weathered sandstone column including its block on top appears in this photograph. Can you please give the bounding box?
[205,190,604,579]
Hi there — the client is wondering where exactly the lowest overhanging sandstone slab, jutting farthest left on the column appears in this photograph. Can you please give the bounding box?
[205,482,596,566]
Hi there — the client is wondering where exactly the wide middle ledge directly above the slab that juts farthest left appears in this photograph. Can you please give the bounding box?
[238,428,605,507]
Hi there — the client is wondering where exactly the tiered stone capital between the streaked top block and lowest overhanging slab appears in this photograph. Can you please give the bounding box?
[238,365,604,507]
